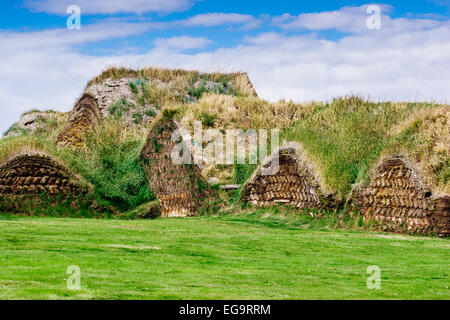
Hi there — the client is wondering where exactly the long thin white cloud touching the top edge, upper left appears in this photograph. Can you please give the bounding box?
[25,0,195,15]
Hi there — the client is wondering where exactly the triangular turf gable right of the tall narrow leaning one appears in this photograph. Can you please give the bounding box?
[242,146,334,209]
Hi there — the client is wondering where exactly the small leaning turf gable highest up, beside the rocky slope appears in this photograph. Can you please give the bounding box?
[56,94,101,148]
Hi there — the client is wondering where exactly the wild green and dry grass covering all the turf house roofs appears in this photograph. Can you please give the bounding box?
[0,63,450,228]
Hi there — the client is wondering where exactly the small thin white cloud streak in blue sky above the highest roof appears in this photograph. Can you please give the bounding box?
[183,13,260,28]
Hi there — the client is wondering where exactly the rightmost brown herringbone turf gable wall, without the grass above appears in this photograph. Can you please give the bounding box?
[352,156,450,236]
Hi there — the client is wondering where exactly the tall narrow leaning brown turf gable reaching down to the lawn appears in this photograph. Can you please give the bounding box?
[140,117,207,217]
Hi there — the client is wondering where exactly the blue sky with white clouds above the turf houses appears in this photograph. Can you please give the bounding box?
[0,0,450,132]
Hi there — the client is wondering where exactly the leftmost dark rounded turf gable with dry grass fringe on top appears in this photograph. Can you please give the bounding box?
[0,137,96,216]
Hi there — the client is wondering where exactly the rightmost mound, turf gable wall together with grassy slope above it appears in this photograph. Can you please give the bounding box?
[342,107,450,236]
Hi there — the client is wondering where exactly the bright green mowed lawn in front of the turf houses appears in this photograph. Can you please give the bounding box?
[0,215,450,299]
